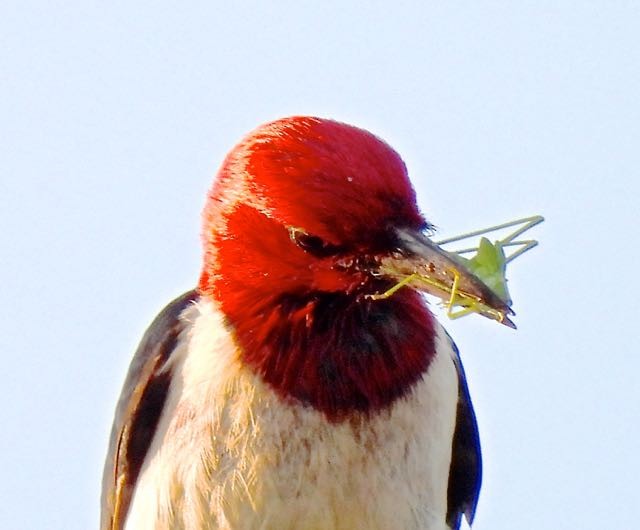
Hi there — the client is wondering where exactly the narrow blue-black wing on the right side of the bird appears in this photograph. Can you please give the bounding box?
[447,337,482,530]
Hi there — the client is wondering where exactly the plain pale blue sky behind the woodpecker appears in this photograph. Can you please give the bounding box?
[0,0,640,530]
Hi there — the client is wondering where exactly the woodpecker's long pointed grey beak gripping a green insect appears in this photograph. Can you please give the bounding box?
[373,229,515,328]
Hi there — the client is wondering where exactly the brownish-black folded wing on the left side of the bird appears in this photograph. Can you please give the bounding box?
[100,291,198,530]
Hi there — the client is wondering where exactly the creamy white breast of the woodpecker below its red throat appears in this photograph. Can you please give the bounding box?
[126,301,458,530]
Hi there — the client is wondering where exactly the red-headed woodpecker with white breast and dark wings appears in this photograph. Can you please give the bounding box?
[101,116,508,530]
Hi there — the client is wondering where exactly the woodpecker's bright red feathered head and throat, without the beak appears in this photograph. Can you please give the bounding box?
[199,117,502,417]
